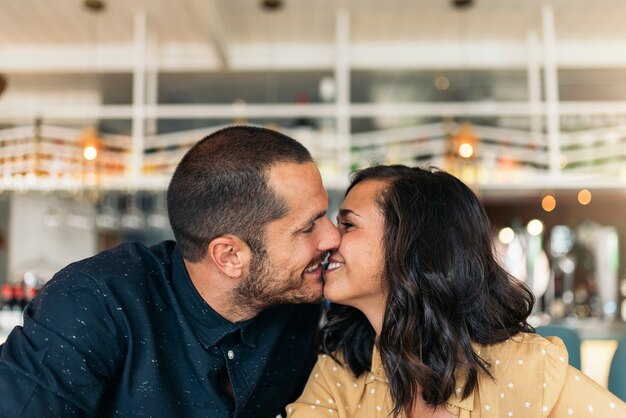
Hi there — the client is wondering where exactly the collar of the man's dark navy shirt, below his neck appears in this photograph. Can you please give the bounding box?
[172,247,257,348]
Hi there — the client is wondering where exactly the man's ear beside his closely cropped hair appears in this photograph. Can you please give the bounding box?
[207,235,251,279]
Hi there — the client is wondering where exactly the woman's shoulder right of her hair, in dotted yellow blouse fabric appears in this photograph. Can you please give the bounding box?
[466,333,624,417]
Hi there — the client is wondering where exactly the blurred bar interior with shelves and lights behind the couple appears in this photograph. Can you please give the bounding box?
[0,0,626,396]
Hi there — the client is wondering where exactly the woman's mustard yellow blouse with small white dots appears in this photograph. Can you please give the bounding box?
[287,333,626,418]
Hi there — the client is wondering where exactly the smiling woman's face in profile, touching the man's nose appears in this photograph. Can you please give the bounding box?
[324,180,385,312]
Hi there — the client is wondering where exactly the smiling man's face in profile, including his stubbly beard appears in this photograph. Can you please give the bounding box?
[236,163,340,307]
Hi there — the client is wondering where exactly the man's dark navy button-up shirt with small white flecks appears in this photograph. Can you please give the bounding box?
[0,242,321,418]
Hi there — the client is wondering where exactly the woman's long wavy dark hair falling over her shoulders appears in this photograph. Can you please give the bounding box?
[322,165,534,416]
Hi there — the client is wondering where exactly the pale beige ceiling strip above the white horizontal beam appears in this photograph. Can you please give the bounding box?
[0,0,626,46]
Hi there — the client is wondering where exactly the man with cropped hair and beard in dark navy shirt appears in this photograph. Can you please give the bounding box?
[0,127,339,418]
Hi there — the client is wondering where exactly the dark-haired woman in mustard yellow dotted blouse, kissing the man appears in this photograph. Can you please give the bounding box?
[287,166,626,418]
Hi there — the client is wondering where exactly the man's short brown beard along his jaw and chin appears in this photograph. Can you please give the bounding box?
[233,249,321,311]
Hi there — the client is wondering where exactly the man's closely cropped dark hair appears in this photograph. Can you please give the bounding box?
[167,126,313,262]
